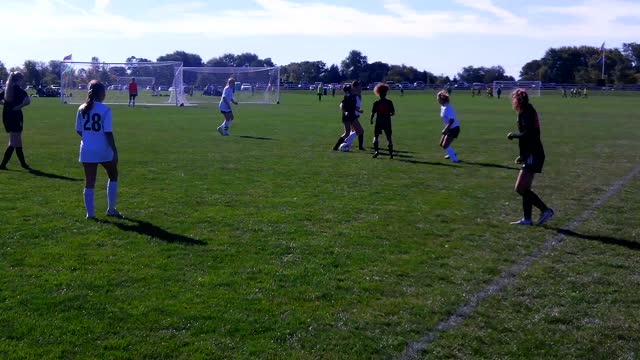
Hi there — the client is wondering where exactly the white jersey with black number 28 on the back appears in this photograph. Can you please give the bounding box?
[76,101,113,163]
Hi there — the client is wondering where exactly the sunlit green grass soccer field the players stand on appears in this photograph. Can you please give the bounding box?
[0,92,640,359]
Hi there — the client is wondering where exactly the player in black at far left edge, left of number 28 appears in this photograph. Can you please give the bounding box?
[0,71,31,170]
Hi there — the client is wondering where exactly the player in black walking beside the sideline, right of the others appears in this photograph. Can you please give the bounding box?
[507,89,554,225]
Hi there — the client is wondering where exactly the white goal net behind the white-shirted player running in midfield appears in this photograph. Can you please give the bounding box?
[171,66,280,106]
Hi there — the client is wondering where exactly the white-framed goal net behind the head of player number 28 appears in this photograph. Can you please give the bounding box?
[60,61,182,106]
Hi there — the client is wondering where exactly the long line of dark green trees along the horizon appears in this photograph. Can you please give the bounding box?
[0,43,640,85]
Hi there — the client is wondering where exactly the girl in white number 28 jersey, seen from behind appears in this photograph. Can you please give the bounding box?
[76,80,122,219]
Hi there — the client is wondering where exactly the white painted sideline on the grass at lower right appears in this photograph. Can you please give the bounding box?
[400,165,640,359]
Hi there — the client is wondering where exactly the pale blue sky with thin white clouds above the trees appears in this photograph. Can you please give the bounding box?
[5,0,640,78]
